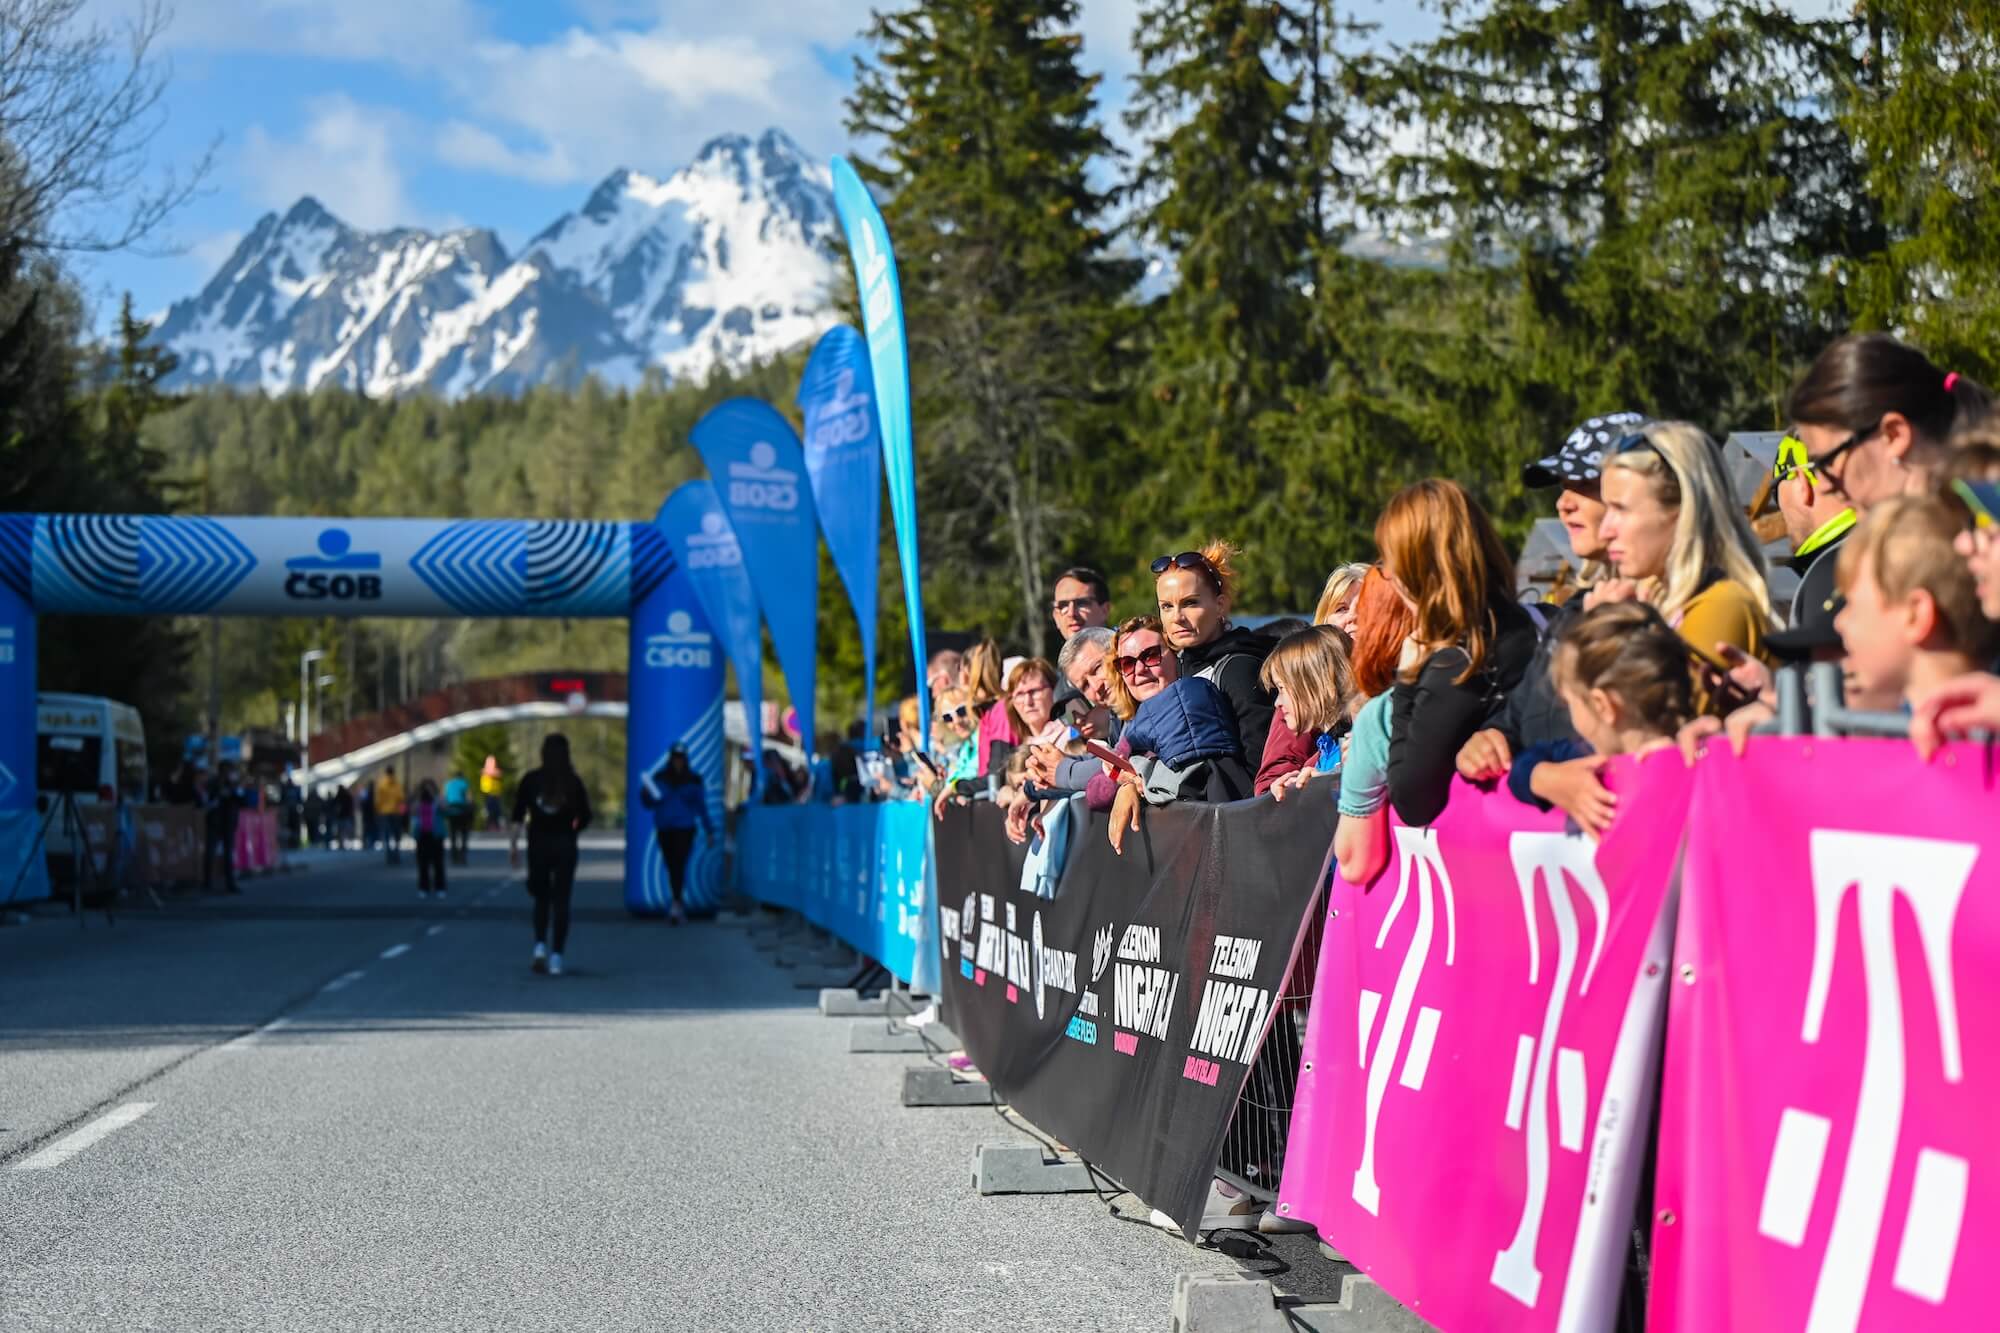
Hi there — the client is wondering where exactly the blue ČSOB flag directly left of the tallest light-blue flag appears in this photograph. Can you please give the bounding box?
[798,324,882,737]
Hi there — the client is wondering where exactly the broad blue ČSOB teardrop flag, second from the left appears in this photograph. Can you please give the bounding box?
[690,398,820,751]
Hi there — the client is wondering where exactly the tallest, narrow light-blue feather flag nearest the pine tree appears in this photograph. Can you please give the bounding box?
[834,158,930,749]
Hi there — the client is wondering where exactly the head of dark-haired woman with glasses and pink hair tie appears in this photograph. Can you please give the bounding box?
[1780,332,1992,514]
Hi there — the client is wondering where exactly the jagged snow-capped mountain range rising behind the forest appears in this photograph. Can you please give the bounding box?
[154,130,838,394]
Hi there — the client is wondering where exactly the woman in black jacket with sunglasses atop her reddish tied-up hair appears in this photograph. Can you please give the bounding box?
[1152,542,1276,768]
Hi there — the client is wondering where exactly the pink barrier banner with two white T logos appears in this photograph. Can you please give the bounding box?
[1278,753,1688,1329]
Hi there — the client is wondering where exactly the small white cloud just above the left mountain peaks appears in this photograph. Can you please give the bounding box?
[236,94,418,228]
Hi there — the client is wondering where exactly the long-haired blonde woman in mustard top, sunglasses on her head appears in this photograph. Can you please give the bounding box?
[1588,420,1772,688]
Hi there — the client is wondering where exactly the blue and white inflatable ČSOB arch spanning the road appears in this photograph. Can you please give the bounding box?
[0,514,724,915]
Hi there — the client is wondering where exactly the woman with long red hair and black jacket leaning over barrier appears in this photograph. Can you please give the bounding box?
[1376,478,1536,825]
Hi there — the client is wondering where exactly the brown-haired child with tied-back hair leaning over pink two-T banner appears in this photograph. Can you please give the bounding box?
[1508,602,1694,839]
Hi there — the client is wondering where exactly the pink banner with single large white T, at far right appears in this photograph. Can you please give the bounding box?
[1648,739,2000,1331]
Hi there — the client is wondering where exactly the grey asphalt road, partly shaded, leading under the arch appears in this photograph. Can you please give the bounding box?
[0,847,1330,1333]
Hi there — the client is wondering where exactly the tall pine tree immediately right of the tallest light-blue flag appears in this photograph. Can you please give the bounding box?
[848,0,1136,642]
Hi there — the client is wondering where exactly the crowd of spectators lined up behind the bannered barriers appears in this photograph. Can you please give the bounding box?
[766,334,2000,881]
